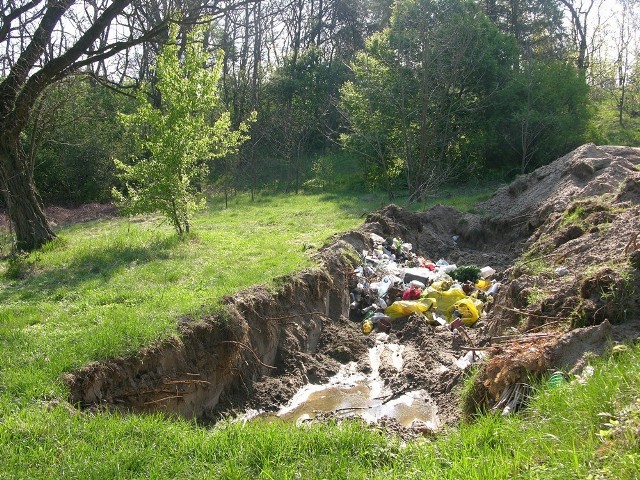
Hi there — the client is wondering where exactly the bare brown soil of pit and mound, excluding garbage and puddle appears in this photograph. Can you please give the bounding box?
[65,145,640,434]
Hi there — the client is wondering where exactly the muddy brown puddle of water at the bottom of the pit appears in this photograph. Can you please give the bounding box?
[270,334,439,429]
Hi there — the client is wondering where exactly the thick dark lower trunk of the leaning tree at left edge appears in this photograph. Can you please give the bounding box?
[0,133,56,251]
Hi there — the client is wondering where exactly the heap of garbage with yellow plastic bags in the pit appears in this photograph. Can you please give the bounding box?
[350,233,500,334]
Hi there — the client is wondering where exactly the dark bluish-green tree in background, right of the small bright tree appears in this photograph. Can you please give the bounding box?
[250,45,347,191]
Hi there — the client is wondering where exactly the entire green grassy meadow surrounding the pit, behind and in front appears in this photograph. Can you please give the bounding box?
[0,192,640,480]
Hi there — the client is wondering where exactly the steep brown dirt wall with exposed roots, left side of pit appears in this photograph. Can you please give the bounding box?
[64,242,354,420]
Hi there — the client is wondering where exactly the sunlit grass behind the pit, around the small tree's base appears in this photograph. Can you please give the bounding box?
[0,195,370,401]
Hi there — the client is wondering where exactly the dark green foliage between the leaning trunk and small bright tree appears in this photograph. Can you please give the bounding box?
[24,76,134,204]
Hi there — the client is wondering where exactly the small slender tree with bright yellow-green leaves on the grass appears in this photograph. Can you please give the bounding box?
[113,29,255,236]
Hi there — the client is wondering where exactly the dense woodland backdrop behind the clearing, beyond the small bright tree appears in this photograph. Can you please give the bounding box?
[0,0,640,204]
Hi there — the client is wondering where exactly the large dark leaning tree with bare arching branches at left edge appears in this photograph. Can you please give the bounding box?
[0,0,252,250]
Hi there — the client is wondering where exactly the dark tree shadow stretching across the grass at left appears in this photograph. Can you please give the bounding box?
[0,235,182,302]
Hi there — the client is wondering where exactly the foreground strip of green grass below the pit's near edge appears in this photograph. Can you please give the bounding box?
[0,340,640,480]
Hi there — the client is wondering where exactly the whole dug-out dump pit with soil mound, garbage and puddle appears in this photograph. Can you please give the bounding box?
[64,144,640,438]
